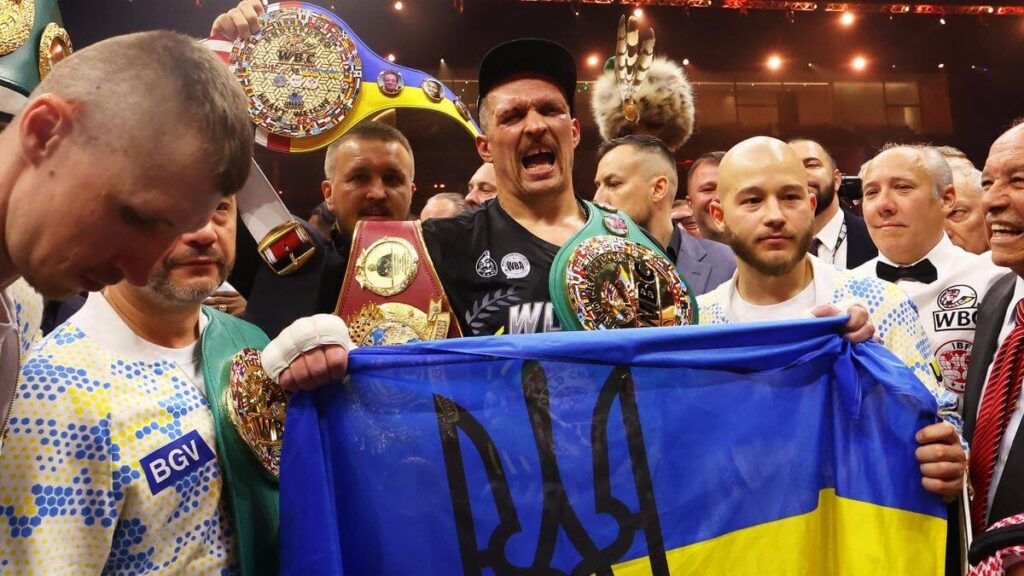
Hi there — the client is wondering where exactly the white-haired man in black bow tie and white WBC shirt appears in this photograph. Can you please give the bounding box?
[858,145,1007,402]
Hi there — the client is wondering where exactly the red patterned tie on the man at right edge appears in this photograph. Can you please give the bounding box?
[971,299,1024,534]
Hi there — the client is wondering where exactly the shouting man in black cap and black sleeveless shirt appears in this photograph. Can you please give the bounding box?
[214,2,587,335]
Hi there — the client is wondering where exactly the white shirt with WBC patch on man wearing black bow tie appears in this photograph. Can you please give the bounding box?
[857,234,1010,409]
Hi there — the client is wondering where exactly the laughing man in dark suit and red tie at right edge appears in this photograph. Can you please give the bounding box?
[964,125,1024,569]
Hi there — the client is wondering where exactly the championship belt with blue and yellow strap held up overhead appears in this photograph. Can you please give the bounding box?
[207,2,479,152]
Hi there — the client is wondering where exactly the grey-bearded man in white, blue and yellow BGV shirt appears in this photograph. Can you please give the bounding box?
[0,198,284,575]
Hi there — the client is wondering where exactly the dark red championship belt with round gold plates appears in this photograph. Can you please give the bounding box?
[335,221,462,346]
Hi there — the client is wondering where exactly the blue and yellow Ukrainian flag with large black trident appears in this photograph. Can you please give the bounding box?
[281,319,946,576]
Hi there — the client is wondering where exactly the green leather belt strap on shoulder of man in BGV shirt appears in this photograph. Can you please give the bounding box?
[203,306,280,576]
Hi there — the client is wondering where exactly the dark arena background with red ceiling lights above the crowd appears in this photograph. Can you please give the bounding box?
[61,0,1024,217]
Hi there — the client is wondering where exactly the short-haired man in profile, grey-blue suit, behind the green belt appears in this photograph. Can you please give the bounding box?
[594,134,736,296]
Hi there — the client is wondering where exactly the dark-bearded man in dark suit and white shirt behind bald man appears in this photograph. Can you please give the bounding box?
[790,138,879,270]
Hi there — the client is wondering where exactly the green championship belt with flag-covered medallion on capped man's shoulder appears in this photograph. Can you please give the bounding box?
[548,202,697,330]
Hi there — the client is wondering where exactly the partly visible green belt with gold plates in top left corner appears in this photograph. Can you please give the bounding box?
[0,0,73,118]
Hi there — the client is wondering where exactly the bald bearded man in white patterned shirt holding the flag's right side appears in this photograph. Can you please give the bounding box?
[697,136,966,498]
